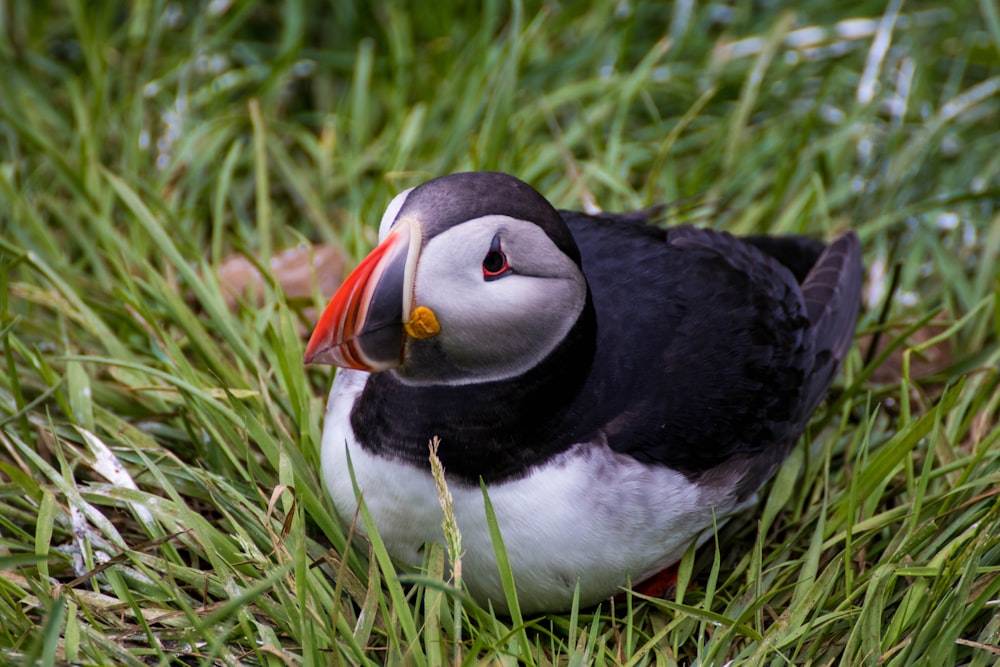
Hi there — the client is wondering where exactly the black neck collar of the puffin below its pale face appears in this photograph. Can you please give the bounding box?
[351,292,597,485]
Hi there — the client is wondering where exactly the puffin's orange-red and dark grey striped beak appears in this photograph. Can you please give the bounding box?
[305,219,421,371]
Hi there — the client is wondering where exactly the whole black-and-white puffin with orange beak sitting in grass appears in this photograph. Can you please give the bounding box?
[305,172,863,613]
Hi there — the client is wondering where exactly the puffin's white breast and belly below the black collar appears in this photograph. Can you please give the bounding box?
[322,370,756,613]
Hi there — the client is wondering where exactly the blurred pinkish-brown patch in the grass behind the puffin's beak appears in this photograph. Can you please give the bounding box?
[219,243,347,330]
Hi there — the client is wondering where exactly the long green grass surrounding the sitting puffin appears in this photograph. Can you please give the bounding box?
[0,0,1000,665]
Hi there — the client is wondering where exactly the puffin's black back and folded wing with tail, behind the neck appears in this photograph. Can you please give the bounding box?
[563,213,861,475]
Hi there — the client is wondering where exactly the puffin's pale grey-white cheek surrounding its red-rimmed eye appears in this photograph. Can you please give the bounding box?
[398,215,587,383]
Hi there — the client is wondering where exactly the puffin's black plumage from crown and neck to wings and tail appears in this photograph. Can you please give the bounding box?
[351,193,861,495]
